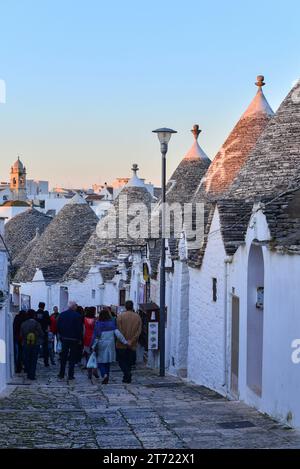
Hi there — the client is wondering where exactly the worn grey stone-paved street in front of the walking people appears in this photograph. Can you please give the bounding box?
[0,365,300,449]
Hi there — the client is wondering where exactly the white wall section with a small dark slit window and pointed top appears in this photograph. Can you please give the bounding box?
[188,209,226,394]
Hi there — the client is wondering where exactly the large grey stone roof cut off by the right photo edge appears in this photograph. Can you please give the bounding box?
[228,82,300,200]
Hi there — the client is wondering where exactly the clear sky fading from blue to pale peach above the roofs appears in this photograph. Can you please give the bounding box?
[0,0,300,186]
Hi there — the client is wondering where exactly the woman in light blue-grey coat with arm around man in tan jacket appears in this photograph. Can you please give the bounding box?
[92,310,130,384]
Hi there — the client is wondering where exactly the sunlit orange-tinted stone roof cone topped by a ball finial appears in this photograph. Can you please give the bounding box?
[196,75,274,200]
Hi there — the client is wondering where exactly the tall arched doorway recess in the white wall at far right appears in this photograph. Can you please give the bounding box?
[247,244,264,396]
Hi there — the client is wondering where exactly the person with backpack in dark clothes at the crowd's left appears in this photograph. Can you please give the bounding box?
[20,309,44,380]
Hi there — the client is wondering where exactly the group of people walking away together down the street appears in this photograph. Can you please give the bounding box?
[14,301,142,384]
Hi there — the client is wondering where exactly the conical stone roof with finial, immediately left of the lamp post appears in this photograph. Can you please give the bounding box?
[64,165,154,281]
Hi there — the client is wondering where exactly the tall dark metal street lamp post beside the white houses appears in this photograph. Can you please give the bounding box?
[153,128,177,376]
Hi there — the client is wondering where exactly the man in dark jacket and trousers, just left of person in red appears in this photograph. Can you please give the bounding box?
[57,301,83,379]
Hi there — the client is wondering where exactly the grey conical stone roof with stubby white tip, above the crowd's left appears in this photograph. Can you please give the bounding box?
[14,195,98,282]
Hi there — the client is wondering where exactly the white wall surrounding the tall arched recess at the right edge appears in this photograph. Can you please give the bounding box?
[228,212,300,427]
